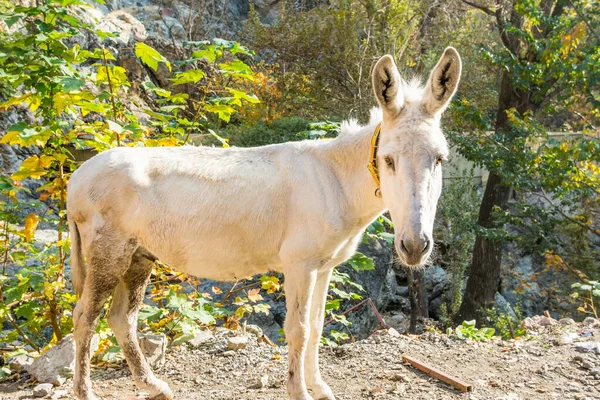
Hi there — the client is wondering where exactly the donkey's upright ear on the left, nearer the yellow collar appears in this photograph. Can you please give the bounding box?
[373,54,404,117]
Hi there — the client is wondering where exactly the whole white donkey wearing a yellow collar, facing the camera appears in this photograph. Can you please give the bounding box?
[68,48,461,400]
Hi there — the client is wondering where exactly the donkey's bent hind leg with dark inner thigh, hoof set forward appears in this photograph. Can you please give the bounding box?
[108,247,173,400]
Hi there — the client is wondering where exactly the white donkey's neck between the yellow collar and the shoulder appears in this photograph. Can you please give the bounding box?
[319,122,385,225]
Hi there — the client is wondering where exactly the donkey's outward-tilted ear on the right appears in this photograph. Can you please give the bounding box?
[423,47,462,115]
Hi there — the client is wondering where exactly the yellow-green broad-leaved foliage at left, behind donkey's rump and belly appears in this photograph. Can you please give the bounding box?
[0,0,260,360]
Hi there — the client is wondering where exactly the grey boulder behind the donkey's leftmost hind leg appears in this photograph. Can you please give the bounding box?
[26,334,100,386]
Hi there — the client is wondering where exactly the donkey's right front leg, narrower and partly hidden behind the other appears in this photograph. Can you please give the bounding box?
[304,268,335,400]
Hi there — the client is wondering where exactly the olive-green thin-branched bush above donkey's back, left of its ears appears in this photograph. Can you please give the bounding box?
[241,0,427,119]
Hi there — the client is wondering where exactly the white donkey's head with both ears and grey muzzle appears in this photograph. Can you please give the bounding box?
[373,47,461,266]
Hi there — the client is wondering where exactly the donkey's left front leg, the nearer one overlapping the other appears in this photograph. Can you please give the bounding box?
[283,264,317,400]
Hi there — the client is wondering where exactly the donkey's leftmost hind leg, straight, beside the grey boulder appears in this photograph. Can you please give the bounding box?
[73,236,135,400]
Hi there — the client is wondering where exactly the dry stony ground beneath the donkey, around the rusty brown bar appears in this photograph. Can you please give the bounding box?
[0,317,600,400]
